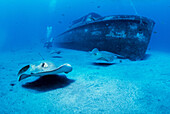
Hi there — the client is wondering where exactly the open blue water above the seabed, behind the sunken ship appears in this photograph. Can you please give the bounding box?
[0,0,170,50]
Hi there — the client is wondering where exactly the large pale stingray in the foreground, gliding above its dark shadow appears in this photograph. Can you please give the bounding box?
[18,61,72,81]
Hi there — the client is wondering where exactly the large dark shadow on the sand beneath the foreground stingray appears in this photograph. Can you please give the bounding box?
[22,75,74,92]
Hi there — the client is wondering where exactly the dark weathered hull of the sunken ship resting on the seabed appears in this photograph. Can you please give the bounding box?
[54,15,155,60]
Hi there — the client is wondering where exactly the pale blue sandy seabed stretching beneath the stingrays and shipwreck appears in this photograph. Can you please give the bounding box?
[0,48,170,114]
